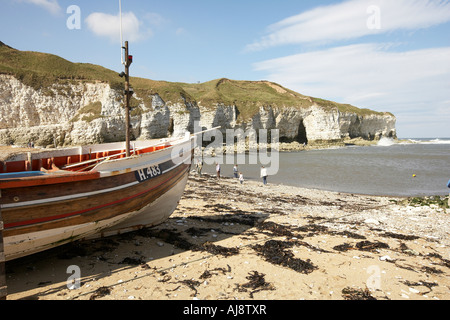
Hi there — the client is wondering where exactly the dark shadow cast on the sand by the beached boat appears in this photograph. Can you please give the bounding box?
[6,209,269,300]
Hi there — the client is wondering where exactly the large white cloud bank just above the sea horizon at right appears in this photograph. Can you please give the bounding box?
[254,43,450,136]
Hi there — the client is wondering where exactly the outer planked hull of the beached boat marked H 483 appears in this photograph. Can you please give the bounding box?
[0,140,192,260]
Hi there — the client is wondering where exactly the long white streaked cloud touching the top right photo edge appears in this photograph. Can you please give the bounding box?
[246,0,450,51]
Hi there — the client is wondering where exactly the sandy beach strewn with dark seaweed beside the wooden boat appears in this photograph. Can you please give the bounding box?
[6,174,450,301]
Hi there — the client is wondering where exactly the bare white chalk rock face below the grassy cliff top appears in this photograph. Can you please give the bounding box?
[0,74,396,147]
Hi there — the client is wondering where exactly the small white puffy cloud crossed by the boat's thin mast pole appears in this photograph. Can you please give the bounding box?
[85,12,152,42]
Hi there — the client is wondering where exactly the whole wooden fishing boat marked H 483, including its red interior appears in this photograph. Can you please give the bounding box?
[0,134,195,261]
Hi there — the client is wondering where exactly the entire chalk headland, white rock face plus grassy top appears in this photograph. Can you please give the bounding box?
[0,42,396,147]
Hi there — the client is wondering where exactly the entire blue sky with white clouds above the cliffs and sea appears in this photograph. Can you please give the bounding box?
[0,0,450,138]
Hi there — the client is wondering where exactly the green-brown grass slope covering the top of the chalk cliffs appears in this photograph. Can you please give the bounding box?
[0,42,390,120]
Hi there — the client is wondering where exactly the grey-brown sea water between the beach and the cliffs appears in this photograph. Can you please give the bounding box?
[203,138,450,196]
